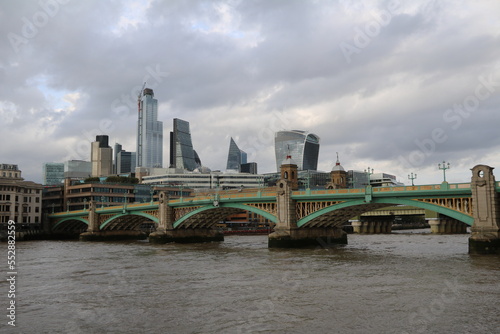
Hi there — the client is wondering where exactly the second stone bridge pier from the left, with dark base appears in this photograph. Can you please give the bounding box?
[149,192,224,244]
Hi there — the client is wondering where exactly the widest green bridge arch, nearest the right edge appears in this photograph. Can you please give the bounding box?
[297,198,474,227]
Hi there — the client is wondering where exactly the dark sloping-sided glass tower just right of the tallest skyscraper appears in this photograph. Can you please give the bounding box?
[170,118,201,171]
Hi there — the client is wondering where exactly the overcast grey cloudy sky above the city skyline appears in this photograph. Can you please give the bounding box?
[0,0,500,184]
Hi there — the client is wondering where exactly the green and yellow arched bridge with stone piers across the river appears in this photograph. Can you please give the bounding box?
[48,165,500,253]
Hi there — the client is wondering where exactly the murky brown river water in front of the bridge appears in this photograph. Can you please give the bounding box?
[0,231,500,334]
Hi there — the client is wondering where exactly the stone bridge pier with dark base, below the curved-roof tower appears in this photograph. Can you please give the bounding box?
[268,180,347,248]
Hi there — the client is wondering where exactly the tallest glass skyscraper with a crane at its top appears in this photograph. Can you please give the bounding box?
[136,88,163,168]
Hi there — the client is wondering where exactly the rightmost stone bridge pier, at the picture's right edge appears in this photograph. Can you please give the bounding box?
[469,165,500,254]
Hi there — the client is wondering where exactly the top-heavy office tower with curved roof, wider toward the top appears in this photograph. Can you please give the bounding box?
[274,130,319,171]
